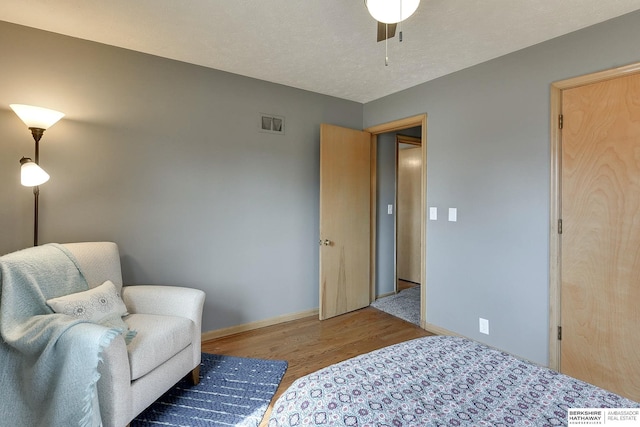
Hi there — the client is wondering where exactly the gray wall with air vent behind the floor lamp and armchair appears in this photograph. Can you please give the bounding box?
[0,22,363,331]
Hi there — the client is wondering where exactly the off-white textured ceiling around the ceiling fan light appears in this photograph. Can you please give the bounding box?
[0,0,640,103]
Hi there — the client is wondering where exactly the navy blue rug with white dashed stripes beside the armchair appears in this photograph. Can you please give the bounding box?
[131,353,287,427]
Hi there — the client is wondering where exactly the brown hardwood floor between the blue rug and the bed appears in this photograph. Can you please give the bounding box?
[202,307,433,426]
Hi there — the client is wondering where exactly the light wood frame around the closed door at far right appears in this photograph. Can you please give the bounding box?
[549,62,640,371]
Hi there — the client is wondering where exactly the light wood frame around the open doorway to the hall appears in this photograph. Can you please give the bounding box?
[364,113,427,329]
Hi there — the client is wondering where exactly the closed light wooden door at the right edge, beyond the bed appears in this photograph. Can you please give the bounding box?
[560,74,640,401]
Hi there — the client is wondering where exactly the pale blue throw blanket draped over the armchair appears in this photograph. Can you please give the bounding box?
[0,244,120,427]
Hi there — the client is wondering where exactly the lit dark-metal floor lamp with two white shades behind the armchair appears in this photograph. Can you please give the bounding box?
[9,104,64,246]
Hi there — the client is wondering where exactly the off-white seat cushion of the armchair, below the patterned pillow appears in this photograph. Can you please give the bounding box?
[124,314,195,381]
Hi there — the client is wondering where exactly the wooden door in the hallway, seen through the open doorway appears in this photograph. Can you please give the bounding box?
[396,147,422,283]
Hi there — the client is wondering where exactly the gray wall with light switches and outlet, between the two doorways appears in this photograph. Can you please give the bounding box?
[364,12,640,364]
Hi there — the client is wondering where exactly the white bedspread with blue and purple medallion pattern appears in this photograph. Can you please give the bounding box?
[269,336,640,427]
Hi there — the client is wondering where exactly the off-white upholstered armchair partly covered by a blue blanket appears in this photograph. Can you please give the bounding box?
[64,242,205,427]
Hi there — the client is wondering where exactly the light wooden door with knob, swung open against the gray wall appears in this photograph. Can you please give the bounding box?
[320,124,371,320]
